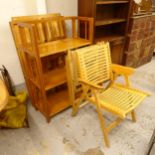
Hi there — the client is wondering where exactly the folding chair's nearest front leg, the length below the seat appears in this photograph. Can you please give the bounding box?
[97,109,110,147]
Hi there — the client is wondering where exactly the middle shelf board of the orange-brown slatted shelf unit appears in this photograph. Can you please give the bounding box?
[44,68,67,91]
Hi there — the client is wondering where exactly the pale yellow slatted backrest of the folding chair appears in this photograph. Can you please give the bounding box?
[76,43,111,84]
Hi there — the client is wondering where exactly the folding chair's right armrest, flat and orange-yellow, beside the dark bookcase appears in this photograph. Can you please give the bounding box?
[112,64,135,76]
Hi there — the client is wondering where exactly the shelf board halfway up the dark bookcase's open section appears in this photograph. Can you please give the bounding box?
[95,18,126,26]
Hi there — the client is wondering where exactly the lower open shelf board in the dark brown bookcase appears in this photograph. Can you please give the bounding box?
[95,34,125,43]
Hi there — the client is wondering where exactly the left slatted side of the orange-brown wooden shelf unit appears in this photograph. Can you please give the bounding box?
[17,23,46,111]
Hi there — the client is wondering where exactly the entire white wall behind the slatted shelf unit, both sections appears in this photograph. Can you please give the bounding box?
[0,0,78,85]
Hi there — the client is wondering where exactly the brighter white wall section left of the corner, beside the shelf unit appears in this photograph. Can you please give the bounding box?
[0,0,46,84]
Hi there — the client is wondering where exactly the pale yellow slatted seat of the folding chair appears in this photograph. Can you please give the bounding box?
[92,84,146,119]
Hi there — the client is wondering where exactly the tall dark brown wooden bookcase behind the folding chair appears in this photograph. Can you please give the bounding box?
[78,0,131,64]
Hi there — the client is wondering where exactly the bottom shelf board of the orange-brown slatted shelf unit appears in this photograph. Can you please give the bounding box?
[47,89,71,116]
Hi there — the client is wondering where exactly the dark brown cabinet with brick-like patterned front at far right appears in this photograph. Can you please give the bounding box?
[124,14,155,67]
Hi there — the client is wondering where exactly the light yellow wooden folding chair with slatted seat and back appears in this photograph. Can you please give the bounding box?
[67,42,149,147]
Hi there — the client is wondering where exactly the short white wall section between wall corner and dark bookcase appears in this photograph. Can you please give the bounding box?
[46,0,78,16]
